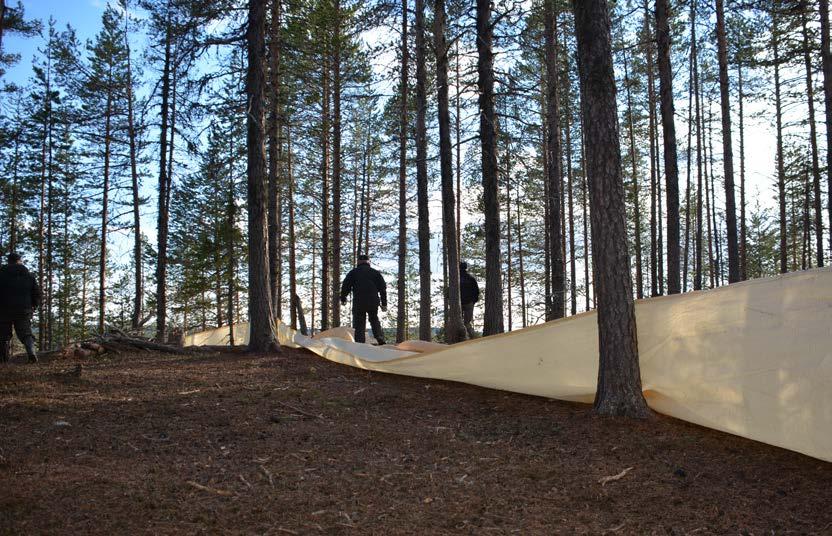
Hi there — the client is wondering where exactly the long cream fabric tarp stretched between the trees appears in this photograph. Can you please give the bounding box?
[186,269,832,461]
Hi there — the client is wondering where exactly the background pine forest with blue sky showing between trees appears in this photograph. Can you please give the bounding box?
[0,0,832,349]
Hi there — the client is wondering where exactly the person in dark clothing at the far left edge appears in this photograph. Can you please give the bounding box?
[0,253,41,363]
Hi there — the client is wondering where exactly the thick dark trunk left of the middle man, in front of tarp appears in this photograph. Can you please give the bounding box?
[246,0,280,352]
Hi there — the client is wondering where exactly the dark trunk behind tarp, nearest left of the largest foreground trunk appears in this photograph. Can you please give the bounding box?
[544,0,566,320]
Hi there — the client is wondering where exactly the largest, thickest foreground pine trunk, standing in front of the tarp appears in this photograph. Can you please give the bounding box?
[572,0,649,417]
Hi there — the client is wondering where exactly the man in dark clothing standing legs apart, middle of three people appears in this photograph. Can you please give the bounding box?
[341,255,387,344]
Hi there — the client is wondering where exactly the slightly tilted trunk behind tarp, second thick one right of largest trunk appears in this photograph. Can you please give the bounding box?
[716,0,741,283]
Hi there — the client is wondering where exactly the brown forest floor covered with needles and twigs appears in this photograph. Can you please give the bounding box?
[0,350,832,535]
